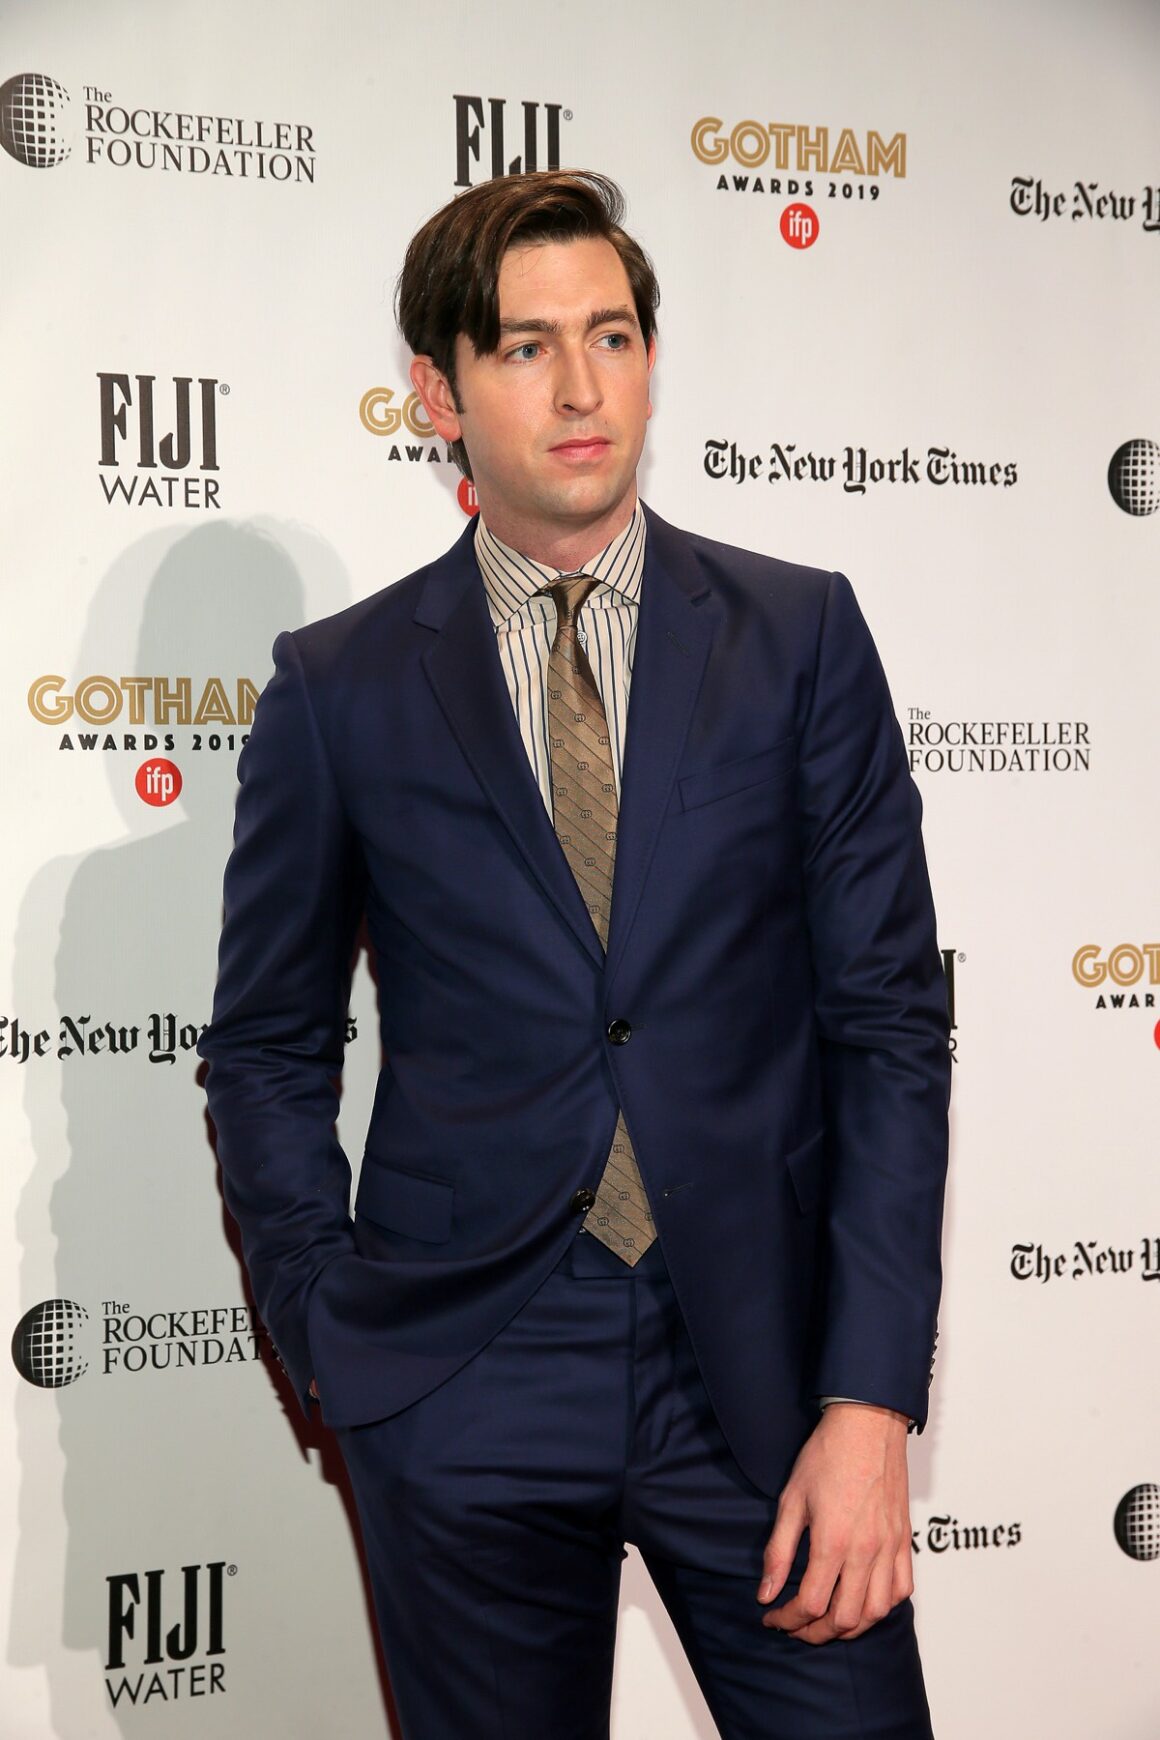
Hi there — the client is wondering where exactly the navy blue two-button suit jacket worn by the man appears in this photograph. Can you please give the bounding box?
[202,513,950,1493]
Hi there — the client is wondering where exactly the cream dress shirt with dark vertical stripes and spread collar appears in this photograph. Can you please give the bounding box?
[475,503,645,816]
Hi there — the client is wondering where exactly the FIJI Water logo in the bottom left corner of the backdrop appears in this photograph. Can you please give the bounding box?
[104,1559,238,1709]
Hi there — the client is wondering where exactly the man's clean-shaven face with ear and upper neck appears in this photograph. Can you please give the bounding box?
[412,240,654,555]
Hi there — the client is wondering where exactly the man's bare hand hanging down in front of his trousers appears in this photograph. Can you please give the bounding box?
[757,1402,915,1643]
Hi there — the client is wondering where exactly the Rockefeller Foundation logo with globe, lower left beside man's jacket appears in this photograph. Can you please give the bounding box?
[12,1300,266,1390]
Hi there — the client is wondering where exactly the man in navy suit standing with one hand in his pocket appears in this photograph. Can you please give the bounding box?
[202,172,950,1740]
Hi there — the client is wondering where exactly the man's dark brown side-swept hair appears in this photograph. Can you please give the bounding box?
[395,169,661,477]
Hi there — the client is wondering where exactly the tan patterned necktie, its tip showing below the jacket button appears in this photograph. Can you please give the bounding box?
[544,574,656,1267]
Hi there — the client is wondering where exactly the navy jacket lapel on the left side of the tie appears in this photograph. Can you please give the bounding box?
[416,525,603,964]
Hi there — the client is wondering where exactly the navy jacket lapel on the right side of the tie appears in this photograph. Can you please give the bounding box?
[608,508,715,974]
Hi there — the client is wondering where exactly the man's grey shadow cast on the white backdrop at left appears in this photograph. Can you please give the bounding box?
[9,522,400,1740]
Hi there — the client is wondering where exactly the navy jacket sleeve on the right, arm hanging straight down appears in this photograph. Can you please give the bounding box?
[800,574,950,1425]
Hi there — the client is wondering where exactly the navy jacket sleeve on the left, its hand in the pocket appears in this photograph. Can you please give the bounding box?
[198,635,363,1404]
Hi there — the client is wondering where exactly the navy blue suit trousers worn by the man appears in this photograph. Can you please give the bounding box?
[339,1235,930,1740]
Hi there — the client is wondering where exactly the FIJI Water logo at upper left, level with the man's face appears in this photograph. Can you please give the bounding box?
[97,372,230,508]
